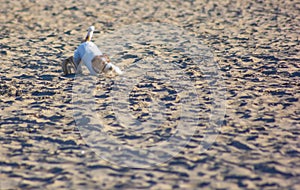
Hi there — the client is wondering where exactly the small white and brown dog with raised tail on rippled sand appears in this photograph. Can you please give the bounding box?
[62,26,123,75]
